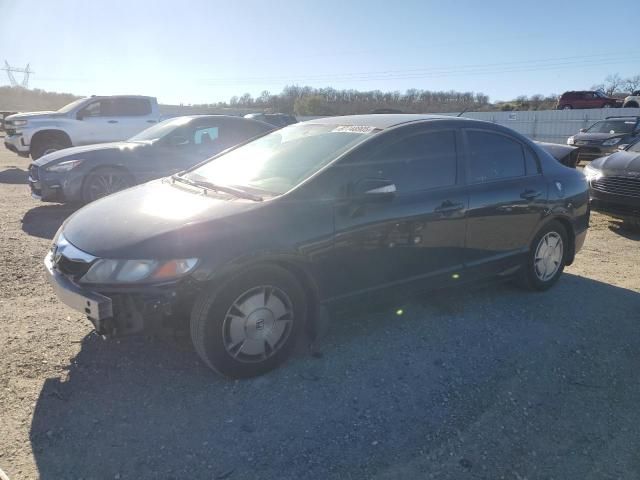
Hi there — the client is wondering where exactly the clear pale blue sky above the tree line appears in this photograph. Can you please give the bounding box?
[0,0,640,104]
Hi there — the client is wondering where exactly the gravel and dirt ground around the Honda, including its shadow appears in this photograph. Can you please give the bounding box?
[0,147,640,480]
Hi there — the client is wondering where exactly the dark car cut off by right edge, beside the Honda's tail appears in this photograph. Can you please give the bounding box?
[584,140,640,230]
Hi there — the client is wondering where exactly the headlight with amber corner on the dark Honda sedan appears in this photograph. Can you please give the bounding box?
[80,258,198,283]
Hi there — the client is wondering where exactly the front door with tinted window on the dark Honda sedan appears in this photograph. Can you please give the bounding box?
[332,126,468,296]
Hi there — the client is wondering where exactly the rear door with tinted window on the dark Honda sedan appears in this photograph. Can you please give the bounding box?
[464,129,547,275]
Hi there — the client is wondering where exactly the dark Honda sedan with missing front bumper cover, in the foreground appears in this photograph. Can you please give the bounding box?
[45,115,589,377]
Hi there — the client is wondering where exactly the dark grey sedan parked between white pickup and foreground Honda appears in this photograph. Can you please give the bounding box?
[29,115,274,203]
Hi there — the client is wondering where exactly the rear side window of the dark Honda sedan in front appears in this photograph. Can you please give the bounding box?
[467,130,526,183]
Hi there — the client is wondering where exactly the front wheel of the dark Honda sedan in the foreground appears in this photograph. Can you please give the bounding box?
[190,265,307,378]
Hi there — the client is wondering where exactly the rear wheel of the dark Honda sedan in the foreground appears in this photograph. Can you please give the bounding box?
[518,220,569,291]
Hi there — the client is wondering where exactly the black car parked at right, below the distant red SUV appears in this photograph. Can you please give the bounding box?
[567,116,640,161]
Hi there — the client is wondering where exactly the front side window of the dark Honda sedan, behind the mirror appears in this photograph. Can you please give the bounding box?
[354,130,457,194]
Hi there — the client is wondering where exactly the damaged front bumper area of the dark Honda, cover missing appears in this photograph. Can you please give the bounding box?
[44,252,199,337]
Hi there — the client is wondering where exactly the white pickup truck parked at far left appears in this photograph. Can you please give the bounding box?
[4,95,160,160]
